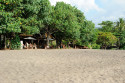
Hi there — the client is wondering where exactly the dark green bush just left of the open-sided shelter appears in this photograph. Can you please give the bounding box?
[10,35,21,50]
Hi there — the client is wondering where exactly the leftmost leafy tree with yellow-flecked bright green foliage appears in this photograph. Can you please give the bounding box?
[0,0,22,48]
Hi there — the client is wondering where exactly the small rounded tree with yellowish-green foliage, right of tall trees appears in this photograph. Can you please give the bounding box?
[97,32,117,49]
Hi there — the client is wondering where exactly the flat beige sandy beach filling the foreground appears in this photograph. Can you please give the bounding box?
[0,49,125,83]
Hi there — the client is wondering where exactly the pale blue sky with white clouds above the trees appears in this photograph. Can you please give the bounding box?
[50,0,125,27]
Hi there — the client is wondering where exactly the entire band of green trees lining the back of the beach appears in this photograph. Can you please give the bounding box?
[0,0,125,49]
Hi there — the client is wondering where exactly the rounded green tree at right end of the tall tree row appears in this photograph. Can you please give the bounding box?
[80,20,97,46]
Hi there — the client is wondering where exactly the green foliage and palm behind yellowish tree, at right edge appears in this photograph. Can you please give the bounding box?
[99,18,125,48]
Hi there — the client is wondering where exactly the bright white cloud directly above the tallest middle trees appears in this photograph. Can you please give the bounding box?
[50,0,104,11]
